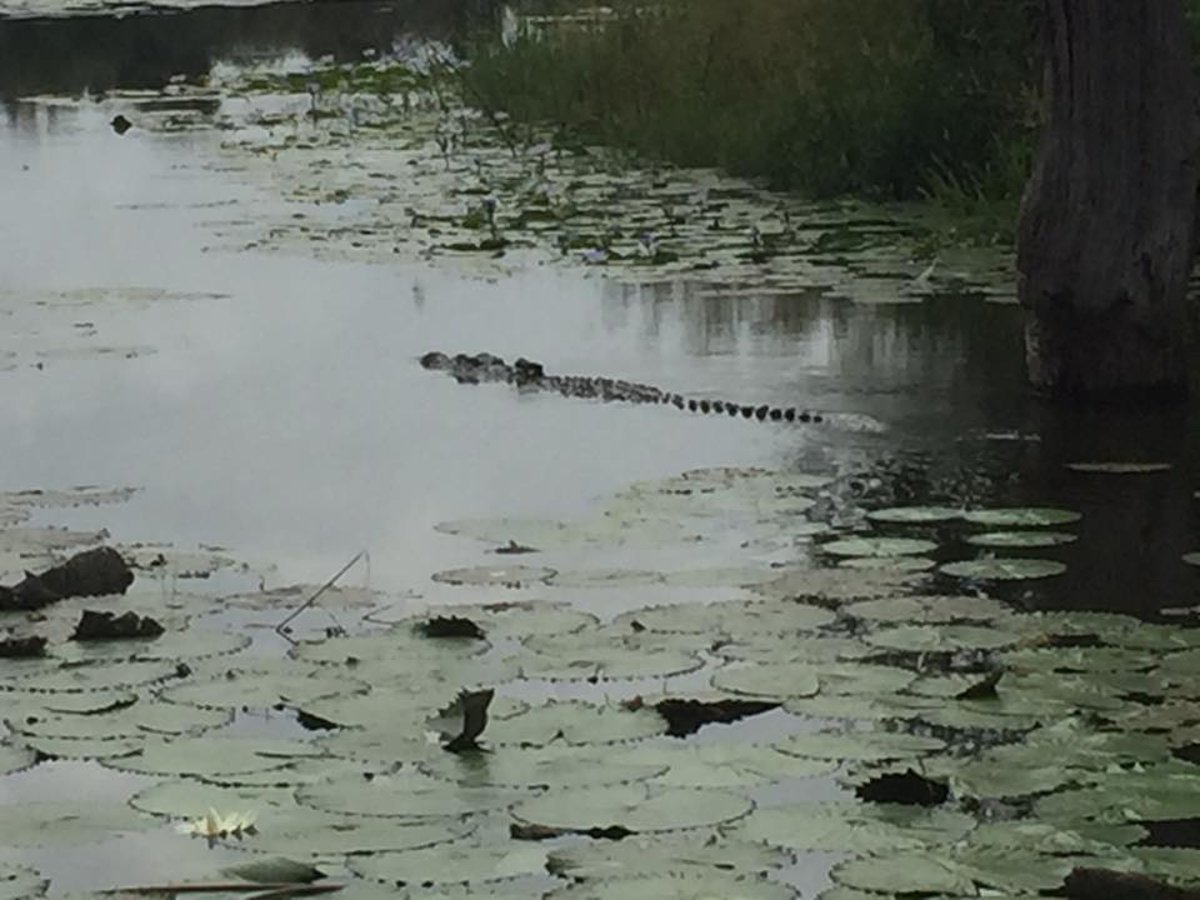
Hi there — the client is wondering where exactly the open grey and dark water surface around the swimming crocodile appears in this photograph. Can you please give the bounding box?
[0,2,1200,628]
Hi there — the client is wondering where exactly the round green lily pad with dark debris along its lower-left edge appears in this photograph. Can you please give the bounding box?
[511,785,754,832]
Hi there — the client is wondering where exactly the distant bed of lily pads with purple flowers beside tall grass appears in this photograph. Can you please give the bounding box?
[75,54,1013,304]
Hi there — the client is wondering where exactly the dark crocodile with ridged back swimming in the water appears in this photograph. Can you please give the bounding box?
[421,350,886,432]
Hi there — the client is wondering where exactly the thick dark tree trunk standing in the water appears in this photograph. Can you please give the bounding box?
[1018,0,1200,397]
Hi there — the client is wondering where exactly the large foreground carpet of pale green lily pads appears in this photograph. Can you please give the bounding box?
[0,469,1200,900]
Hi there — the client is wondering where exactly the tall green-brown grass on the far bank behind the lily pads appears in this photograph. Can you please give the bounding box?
[468,0,1036,198]
